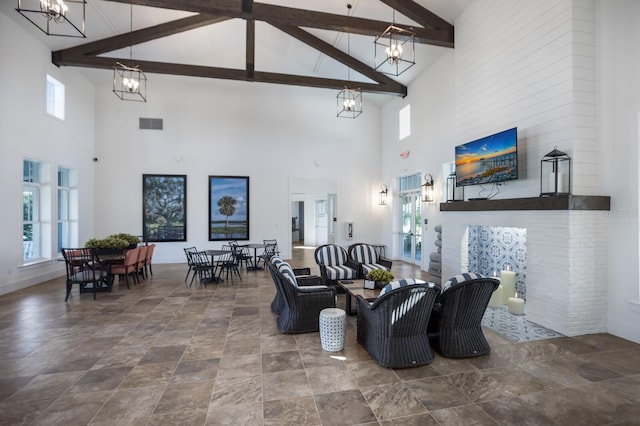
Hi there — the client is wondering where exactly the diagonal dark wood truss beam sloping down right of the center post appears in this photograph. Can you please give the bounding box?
[274,25,407,93]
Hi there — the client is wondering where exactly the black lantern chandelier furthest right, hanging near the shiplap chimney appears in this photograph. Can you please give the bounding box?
[373,9,416,77]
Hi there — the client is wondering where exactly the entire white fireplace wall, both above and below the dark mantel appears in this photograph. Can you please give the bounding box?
[442,0,608,335]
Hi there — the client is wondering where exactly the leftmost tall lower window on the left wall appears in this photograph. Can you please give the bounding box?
[22,160,41,261]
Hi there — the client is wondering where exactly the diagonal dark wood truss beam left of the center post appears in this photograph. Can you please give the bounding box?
[54,15,229,55]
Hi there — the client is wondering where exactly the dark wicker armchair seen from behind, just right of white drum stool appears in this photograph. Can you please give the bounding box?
[356,280,440,368]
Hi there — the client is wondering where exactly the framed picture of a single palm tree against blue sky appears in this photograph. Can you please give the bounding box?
[209,176,249,241]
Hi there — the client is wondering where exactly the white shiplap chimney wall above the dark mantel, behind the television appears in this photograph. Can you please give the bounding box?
[455,0,598,198]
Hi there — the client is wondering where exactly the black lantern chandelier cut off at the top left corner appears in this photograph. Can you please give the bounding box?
[16,0,87,38]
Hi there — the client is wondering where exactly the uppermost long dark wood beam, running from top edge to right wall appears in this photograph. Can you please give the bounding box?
[96,0,454,47]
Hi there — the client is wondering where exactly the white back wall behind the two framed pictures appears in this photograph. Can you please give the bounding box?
[95,75,388,263]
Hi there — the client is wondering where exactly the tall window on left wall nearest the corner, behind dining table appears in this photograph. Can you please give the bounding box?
[57,167,78,254]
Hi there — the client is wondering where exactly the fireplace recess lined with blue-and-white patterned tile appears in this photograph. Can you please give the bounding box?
[462,225,527,299]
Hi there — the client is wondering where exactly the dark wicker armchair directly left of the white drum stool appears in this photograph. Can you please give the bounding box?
[267,262,336,333]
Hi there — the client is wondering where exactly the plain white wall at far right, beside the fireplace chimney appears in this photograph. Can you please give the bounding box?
[597,0,640,342]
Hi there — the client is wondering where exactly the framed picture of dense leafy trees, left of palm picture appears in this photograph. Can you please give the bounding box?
[142,174,187,242]
